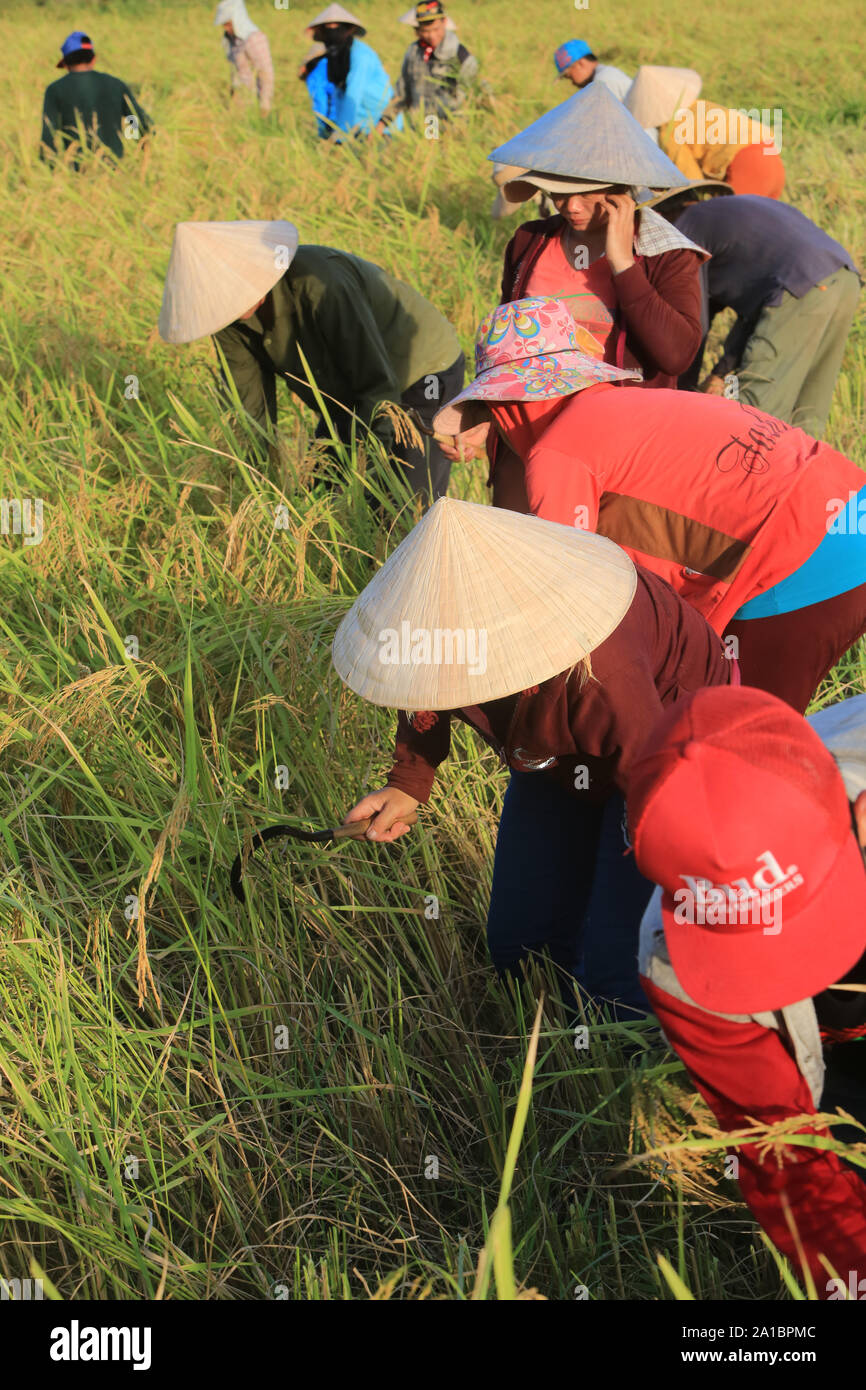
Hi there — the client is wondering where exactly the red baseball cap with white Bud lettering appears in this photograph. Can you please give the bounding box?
[628,687,866,1013]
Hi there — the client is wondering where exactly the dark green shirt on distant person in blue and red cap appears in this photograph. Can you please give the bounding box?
[42,71,152,160]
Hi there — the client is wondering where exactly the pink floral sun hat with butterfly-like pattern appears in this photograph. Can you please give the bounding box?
[434,299,642,435]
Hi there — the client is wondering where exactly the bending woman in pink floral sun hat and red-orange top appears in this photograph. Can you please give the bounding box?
[434,299,866,713]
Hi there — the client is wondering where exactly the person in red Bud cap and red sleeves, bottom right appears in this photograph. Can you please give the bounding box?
[628,688,866,1298]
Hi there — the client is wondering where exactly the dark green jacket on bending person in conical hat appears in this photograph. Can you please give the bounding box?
[215,246,460,449]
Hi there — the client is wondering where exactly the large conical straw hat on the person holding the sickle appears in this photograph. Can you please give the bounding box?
[332,498,637,710]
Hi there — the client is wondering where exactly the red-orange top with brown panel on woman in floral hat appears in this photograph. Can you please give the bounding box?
[524,385,866,632]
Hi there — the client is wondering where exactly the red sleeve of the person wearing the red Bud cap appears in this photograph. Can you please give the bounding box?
[641,976,866,1298]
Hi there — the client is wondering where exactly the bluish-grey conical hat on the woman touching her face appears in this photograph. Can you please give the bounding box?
[488,82,683,188]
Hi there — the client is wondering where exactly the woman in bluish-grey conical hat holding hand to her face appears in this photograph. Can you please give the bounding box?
[452,83,706,510]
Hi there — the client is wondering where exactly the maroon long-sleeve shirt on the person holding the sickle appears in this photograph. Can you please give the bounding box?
[388,567,735,802]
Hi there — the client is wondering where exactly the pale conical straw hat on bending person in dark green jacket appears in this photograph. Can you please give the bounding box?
[160,221,297,343]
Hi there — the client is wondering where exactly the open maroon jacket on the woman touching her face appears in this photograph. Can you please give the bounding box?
[502,214,703,388]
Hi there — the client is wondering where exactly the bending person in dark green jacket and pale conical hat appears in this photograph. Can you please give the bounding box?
[160,221,464,498]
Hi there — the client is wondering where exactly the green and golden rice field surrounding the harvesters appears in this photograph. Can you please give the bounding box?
[0,0,866,1301]
